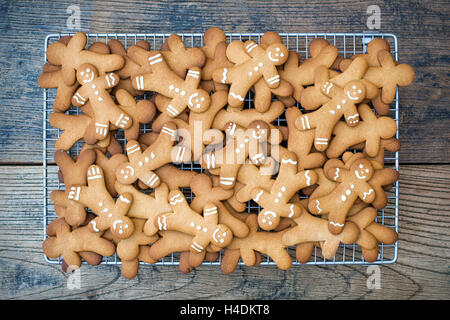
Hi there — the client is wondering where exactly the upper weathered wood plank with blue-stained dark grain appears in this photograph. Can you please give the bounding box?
[0,0,450,163]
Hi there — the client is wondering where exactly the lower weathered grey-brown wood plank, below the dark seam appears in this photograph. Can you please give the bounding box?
[0,165,450,299]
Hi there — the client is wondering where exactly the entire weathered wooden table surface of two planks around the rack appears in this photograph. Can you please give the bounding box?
[0,0,450,299]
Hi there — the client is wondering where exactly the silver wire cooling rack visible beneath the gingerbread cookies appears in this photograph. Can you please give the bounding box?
[42,33,399,266]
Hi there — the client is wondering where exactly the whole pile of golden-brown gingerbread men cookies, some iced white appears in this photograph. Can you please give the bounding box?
[38,28,414,278]
